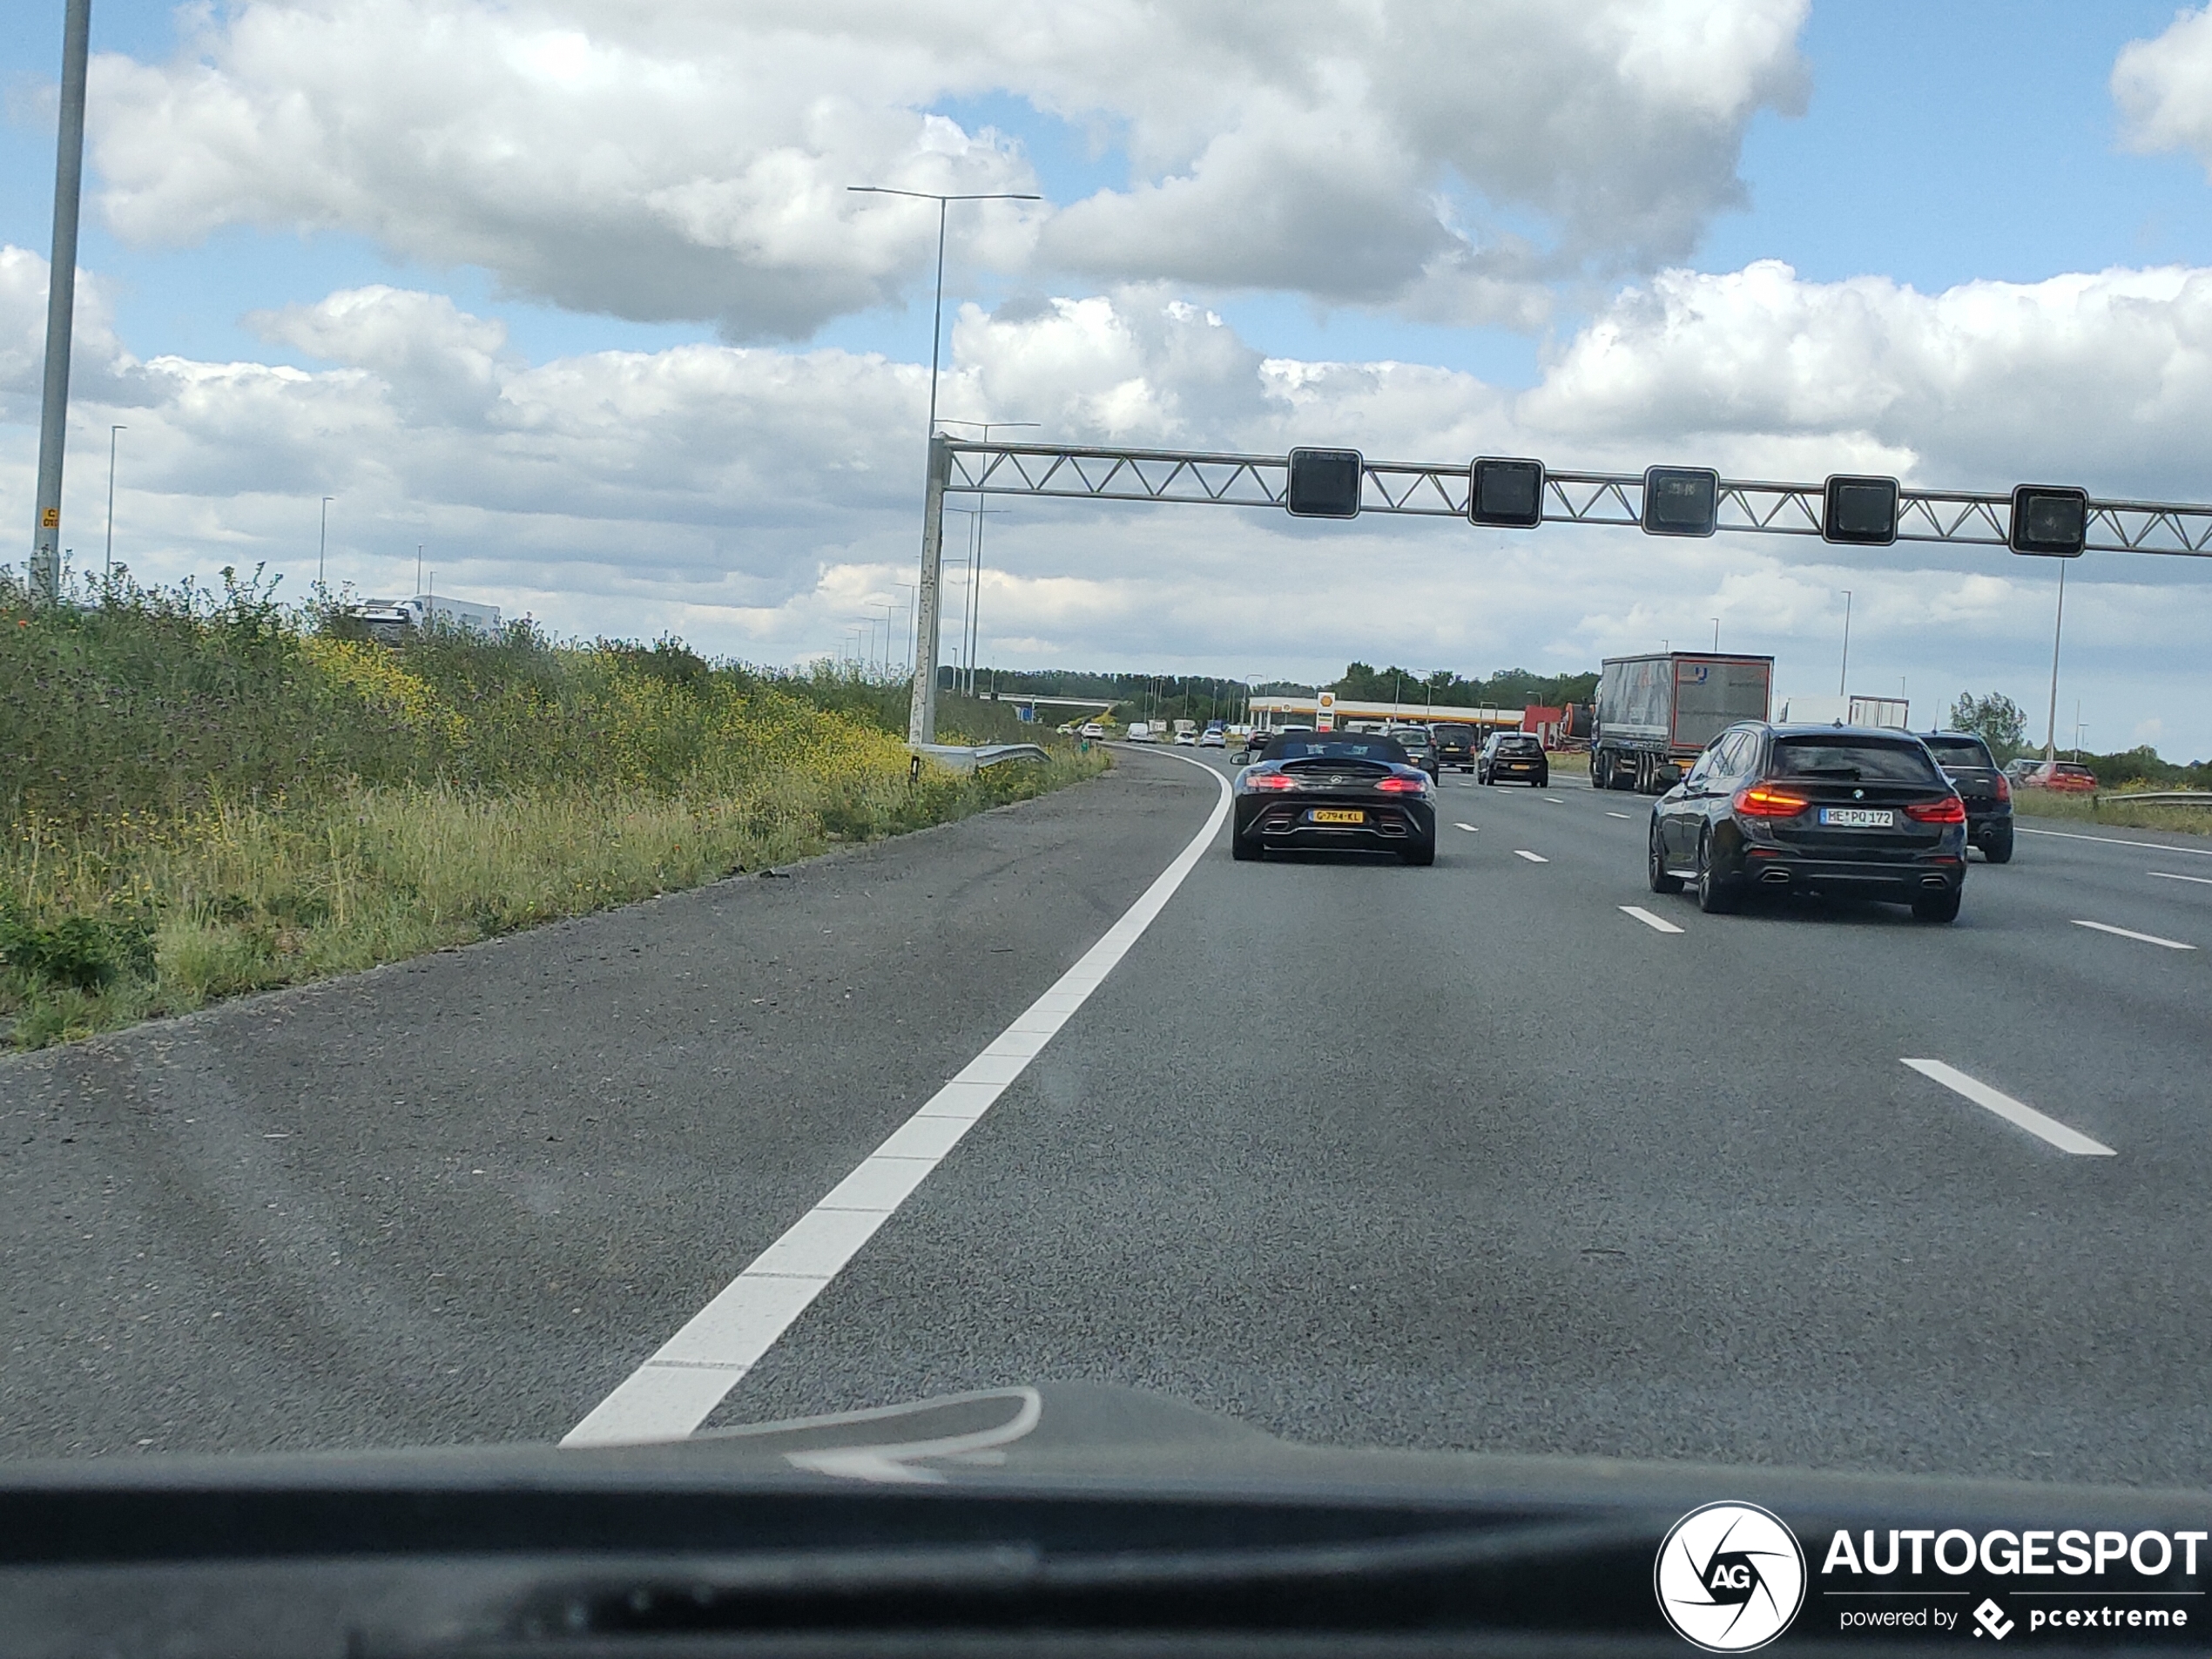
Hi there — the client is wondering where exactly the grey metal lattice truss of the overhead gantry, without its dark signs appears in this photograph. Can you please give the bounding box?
[945,438,2212,557]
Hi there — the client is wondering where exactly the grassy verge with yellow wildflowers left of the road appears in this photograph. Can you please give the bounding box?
[0,577,1109,1049]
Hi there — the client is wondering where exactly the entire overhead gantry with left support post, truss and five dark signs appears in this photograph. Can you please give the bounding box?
[907,435,2212,743]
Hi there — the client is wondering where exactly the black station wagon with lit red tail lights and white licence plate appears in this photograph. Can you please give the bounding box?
[1646,724,1966,922]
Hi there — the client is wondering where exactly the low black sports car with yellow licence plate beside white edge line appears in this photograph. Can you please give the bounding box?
[1230,732,1435,865]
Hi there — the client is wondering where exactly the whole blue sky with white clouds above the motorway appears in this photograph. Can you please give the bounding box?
[0,0,2212,759]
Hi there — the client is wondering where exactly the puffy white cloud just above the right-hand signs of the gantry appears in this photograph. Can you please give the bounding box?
[1517,261,2212,500]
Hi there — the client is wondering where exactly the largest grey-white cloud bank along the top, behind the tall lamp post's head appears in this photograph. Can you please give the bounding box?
[93,0,1805,339]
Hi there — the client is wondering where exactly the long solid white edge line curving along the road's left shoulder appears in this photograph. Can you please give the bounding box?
[562,754,1232,1447]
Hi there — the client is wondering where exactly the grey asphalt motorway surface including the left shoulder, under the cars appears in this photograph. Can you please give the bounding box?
[0,750,2212,1484]
